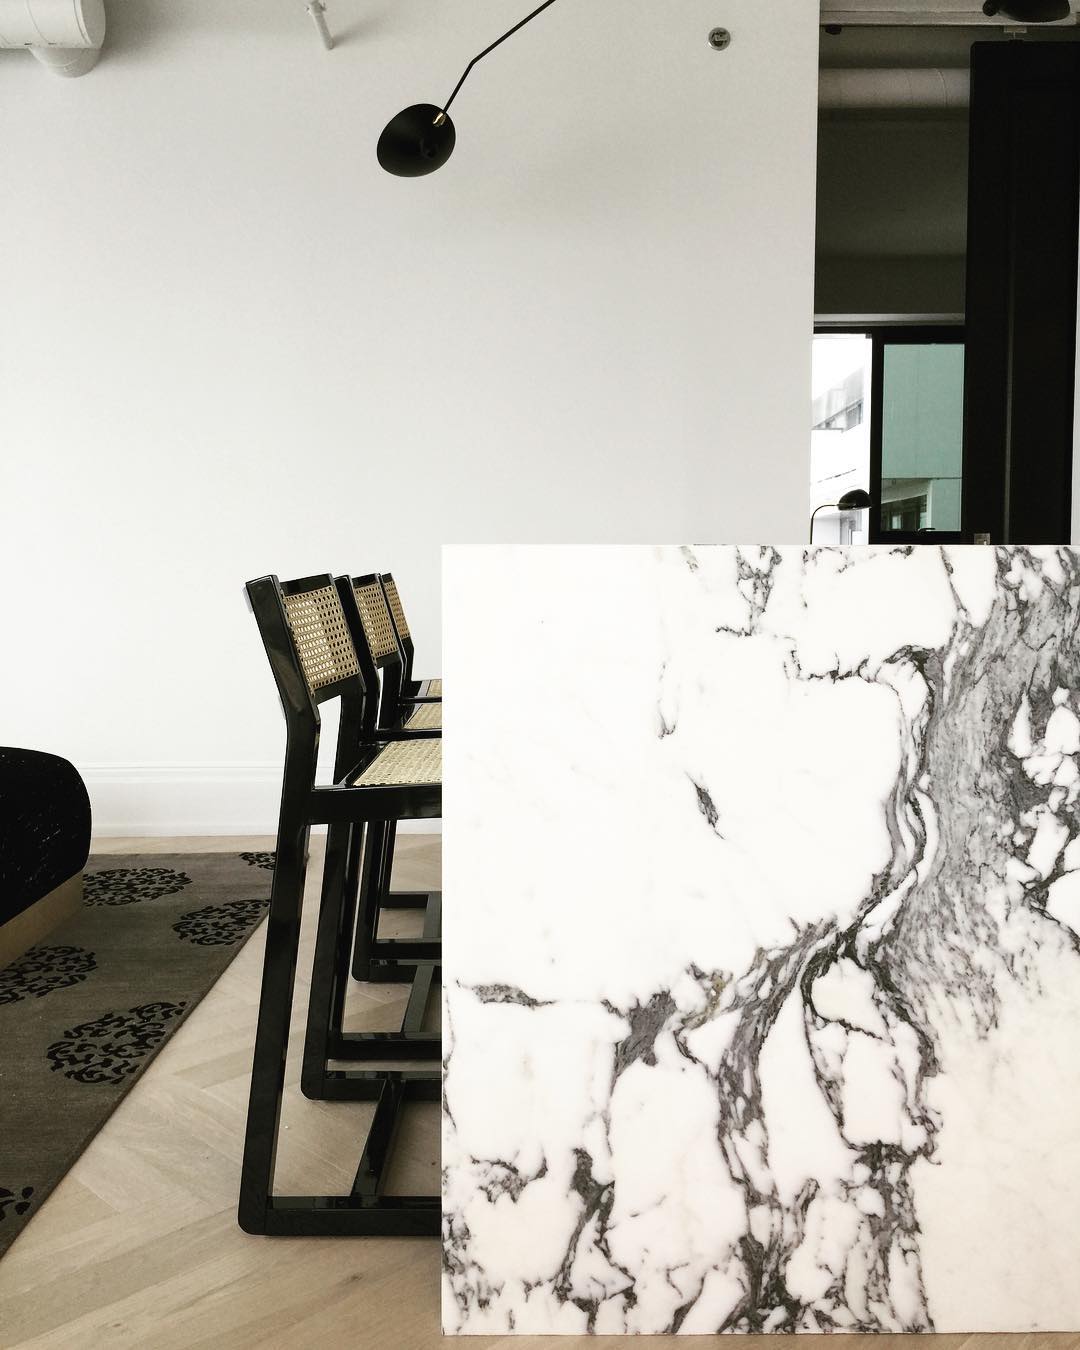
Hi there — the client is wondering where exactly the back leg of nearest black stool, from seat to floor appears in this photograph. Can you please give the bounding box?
[238,819,311,1233]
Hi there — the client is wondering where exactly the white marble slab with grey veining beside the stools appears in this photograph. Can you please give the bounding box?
[443,547,1080,1334]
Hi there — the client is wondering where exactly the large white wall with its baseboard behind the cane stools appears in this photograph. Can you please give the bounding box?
[0,0,817,833]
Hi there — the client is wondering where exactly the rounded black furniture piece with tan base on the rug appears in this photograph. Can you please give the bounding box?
[0,745,90,967]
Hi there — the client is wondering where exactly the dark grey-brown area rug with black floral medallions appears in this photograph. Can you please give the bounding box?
[0,853,273,1254]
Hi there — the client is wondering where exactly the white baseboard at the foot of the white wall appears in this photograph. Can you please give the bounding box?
[77,764,443,838]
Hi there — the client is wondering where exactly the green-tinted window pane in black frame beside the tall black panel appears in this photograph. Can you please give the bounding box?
[882,343,964,531]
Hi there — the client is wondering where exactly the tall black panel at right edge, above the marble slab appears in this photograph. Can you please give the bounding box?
[963,42,1080,544]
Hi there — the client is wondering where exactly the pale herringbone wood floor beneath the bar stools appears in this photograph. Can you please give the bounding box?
[0,836,1080,1350]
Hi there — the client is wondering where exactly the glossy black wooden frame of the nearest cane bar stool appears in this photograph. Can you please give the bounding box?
[238,575,441,1237]
